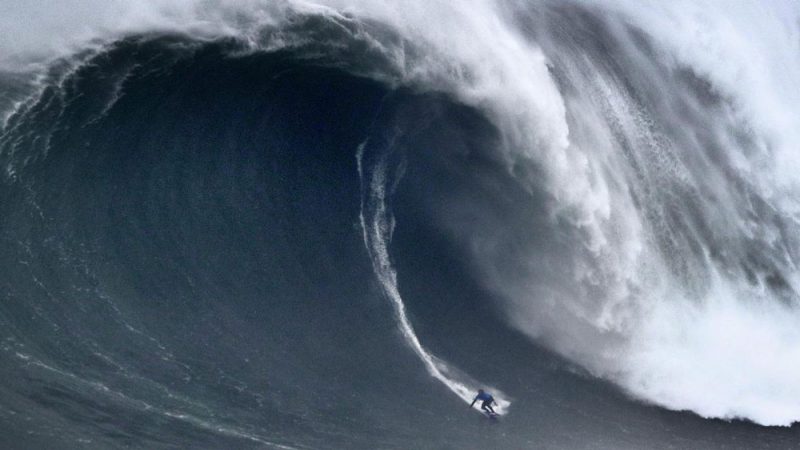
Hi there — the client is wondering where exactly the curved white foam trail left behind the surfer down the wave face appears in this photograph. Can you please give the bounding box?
[356,141,511,414]
